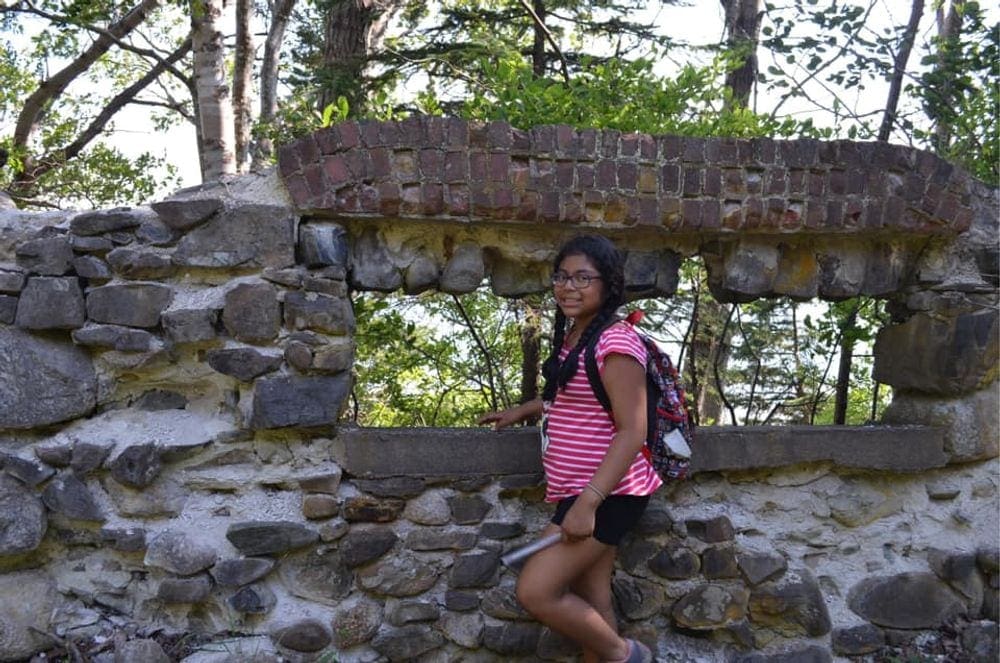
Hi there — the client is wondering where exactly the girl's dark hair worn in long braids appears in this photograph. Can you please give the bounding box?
[542,235,625,401]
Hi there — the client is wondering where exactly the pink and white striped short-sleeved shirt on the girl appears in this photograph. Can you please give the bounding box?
[542,323,663,502]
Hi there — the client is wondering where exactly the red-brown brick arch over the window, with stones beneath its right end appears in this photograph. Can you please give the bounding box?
[279,117,977,301]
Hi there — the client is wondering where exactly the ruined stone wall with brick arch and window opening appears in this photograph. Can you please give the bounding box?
[0,118,1000,663]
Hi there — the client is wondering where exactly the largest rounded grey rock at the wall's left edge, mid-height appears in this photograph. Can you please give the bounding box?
[0,327,97,429]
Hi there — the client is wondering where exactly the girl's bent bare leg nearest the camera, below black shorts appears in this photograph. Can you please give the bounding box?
[517,524,628,661]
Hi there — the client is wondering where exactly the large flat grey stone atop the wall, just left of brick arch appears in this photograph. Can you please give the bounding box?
[173,205,297,268]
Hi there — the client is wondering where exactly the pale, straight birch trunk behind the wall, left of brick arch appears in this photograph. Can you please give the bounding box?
[191,0,236,182]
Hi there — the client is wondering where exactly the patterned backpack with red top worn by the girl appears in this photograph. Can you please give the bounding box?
[584,311,694,482]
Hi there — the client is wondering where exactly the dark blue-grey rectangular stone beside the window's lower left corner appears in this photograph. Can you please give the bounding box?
[250,372,351,429]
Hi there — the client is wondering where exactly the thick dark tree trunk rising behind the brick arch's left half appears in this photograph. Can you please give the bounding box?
[319,0,402,110]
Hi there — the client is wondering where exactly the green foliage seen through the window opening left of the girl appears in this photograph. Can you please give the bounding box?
[352,290,522,426]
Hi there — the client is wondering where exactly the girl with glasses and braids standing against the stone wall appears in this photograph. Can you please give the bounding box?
[479,235,661,663]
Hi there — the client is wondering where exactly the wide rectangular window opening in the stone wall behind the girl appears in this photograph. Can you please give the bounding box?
[345,259,891,427]
